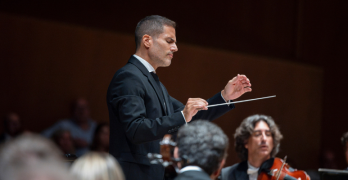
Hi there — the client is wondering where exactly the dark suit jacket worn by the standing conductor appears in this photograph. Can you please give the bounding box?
[107,56,234,180]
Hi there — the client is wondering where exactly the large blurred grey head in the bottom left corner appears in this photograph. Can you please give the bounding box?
[0,134,69,180]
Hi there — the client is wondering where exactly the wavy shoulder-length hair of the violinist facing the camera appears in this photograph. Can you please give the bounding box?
[234,114,283,161]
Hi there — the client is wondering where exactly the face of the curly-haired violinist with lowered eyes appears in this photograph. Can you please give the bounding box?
[245,121,273,159]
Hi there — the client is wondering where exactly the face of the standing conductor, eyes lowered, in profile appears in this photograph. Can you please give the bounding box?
[149,26,178,69]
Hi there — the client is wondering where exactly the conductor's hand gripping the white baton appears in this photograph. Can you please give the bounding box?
[183,98,208,122]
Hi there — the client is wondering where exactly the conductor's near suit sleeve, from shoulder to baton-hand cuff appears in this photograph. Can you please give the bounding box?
[108,72,185,144]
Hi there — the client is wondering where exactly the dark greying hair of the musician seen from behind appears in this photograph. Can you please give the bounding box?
[177,120,228,175]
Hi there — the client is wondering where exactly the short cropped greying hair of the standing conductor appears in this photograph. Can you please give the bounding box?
[135,15,176,50]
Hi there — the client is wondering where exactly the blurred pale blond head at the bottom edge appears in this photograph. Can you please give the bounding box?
[70,152,125,180]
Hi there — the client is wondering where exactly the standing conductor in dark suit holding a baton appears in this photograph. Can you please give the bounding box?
[107,16,251,180]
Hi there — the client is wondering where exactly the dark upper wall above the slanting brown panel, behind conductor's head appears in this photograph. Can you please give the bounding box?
[0,0,299,58]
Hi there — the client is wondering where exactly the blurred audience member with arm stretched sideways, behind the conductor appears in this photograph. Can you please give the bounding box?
[42,98,96,157]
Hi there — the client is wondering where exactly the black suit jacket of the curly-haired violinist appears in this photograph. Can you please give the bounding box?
[220,158,274,180]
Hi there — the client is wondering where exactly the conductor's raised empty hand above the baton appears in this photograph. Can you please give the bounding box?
[221,74,251,100]
